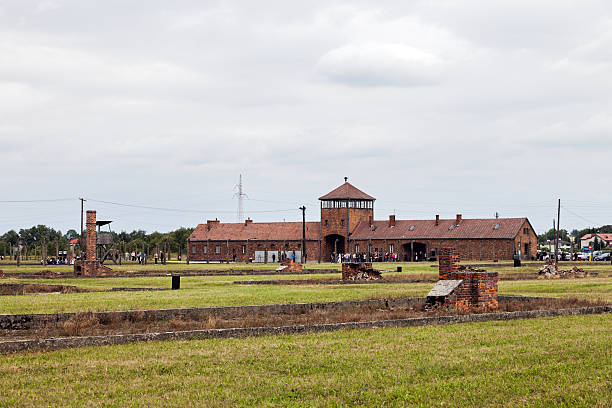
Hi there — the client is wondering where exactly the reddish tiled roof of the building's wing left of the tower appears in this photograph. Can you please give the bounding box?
[189,222,321,241]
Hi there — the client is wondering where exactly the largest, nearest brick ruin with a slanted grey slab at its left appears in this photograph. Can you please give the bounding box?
[427,248,498,312]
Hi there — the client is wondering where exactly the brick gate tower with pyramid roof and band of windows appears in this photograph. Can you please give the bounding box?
[319,177,376,261]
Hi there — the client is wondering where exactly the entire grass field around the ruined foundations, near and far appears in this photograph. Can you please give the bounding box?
[0,263,612,407]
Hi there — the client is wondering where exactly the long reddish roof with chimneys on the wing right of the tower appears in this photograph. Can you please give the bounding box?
[351,218,529,240]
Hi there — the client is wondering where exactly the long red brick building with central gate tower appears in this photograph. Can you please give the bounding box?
[188,180,537,262]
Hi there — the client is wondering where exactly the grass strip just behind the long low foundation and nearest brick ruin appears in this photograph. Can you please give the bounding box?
[0,275,612,314]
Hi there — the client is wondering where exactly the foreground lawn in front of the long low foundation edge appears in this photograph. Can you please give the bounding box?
[0,315,612,407]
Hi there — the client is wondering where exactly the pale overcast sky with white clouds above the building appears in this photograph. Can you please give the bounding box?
[0,0,612,234]
